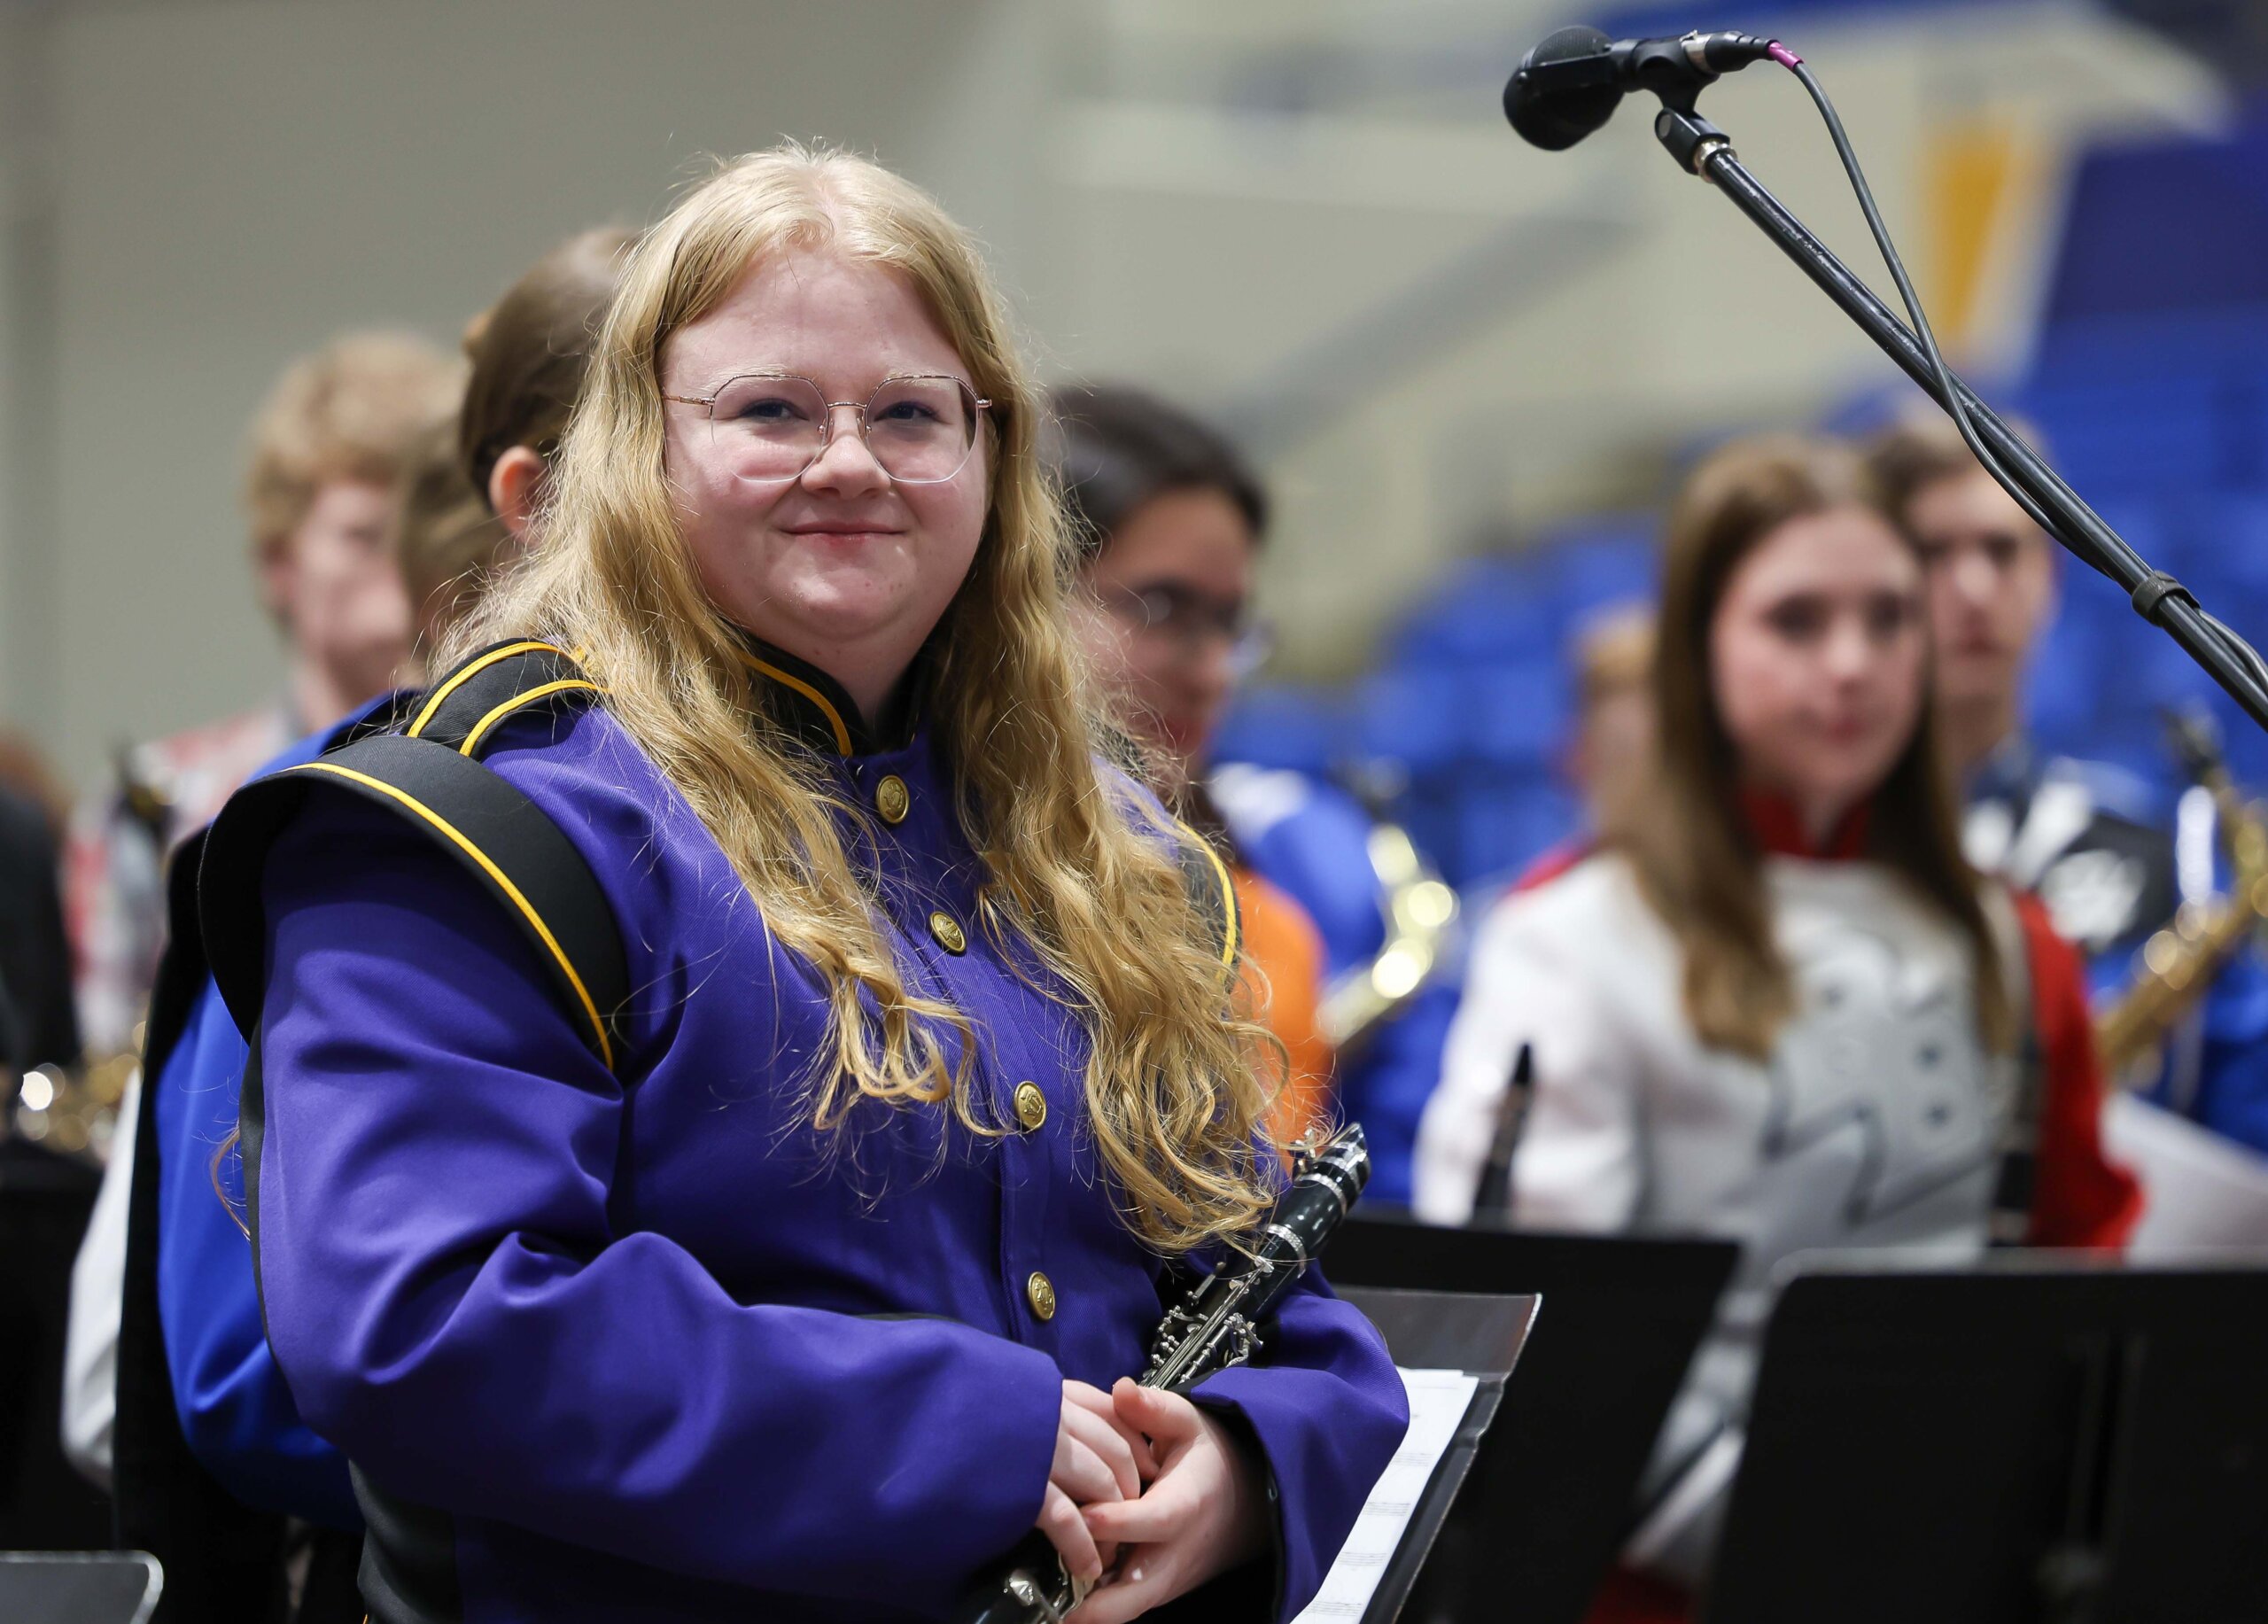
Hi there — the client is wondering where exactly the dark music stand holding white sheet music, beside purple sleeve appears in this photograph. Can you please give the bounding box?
[1332,1278,1538,1624]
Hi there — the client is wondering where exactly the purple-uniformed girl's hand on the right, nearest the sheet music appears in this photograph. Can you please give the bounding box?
[1073,1381,1268,1624]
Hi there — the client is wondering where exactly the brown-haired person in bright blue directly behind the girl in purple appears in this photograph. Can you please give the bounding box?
[87,231,633,1624]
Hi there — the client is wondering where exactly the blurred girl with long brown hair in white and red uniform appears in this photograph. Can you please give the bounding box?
[1418,440,2137,1617]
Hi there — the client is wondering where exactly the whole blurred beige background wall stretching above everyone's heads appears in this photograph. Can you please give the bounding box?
[0,0,2214,781]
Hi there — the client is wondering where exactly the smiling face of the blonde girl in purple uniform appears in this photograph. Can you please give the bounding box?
[663,250,989,717]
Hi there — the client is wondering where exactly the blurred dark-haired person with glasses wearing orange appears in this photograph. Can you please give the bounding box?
[1052,388,1332,1143]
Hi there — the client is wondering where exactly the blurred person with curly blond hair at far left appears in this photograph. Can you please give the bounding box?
[66,333,461,1060]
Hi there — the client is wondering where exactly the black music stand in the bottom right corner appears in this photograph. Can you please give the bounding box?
[1704,1255,2268,1624]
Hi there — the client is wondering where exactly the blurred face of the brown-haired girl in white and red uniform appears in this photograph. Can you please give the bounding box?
[1710,506,1928,835]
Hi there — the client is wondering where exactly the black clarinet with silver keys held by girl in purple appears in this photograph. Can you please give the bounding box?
[952,1125,1370,1624]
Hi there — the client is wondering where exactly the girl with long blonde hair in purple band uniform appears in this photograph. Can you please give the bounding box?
[204,150,1406,1624]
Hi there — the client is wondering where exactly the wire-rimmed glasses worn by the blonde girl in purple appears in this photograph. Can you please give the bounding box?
[663,372,991,486]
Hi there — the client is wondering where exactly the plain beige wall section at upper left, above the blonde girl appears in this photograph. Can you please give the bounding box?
[4,0,1038,778]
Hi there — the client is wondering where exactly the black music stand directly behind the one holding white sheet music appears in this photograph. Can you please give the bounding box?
[1324,1211,1740,1624]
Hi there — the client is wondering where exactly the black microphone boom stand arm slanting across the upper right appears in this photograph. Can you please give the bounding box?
[1653,93,2268,730]
